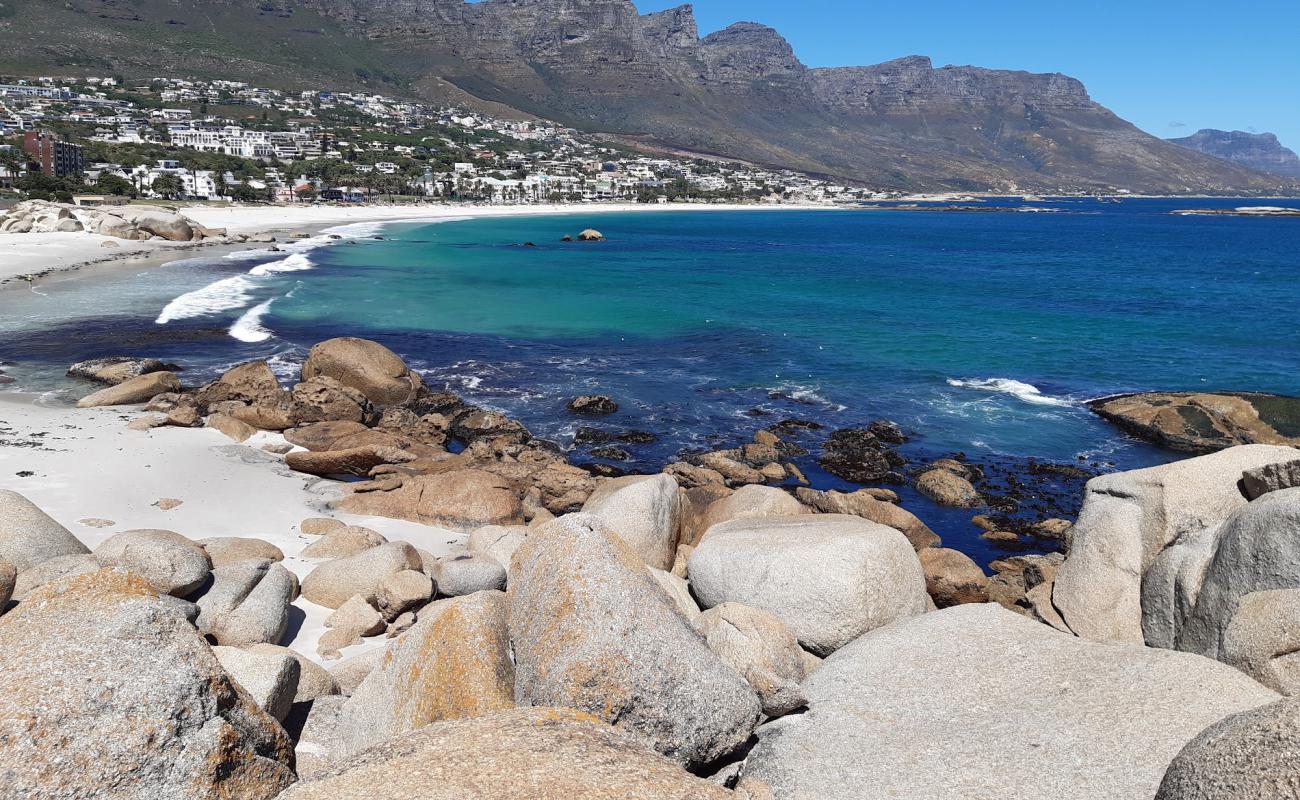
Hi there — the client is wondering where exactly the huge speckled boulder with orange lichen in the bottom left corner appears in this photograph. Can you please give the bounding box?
[0,570,294,800]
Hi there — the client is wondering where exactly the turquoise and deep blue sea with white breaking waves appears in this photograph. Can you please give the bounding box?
[0,199,1300,561]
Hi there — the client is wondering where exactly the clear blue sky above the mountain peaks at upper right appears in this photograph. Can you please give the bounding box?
[634,0,1300,151]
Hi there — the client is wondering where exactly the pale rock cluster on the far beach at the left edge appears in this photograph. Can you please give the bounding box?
[0,200,226,242]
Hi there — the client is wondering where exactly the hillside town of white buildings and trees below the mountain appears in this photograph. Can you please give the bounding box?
[0,77,889,204]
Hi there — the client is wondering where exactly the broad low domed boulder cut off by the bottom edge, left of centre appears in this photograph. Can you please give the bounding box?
[280,708,741,800]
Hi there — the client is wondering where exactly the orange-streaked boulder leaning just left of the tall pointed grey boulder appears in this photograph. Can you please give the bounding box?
[337,592,515,754]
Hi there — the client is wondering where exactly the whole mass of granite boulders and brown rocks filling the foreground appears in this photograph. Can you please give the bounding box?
[0,338,1300,800]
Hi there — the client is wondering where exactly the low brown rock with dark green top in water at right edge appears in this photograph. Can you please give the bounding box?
[1088,392,1300,453]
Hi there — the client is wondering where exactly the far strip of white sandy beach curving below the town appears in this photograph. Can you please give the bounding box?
[0,203,840,297]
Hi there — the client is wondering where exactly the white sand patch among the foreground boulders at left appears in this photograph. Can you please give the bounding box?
[0,394,465,666]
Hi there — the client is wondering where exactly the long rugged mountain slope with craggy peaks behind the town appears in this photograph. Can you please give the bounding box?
[0,0,1283,194]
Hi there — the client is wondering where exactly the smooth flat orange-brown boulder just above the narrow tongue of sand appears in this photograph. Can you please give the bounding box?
[338,470,524,531]
